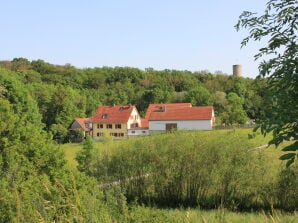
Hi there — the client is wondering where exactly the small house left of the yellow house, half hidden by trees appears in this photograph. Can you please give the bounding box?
[69,118,92,141]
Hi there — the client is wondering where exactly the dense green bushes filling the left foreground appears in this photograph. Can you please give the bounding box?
[0,70,126,222]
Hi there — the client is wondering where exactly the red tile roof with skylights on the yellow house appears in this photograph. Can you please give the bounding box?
[92,105,136,123]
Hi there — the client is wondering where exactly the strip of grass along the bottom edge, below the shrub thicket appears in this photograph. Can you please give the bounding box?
[130,206,298,223]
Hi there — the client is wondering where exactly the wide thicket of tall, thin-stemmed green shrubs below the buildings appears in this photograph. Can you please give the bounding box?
[64,129,298,211]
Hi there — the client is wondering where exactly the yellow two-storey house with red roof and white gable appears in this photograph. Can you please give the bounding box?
[92,105,141,140]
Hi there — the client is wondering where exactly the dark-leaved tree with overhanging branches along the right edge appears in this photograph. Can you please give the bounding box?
[235,0,298,166]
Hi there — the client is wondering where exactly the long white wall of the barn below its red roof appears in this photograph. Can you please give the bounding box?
[149,120,212,131]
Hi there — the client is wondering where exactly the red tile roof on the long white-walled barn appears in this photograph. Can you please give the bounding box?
[148,104,213,121]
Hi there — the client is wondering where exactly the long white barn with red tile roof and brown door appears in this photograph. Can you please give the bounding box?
[145,103,215,134]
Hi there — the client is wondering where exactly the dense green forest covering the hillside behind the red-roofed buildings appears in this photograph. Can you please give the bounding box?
[0,58,266,142]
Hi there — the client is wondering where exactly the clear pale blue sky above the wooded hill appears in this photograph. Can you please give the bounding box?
[0,0,266,78]
